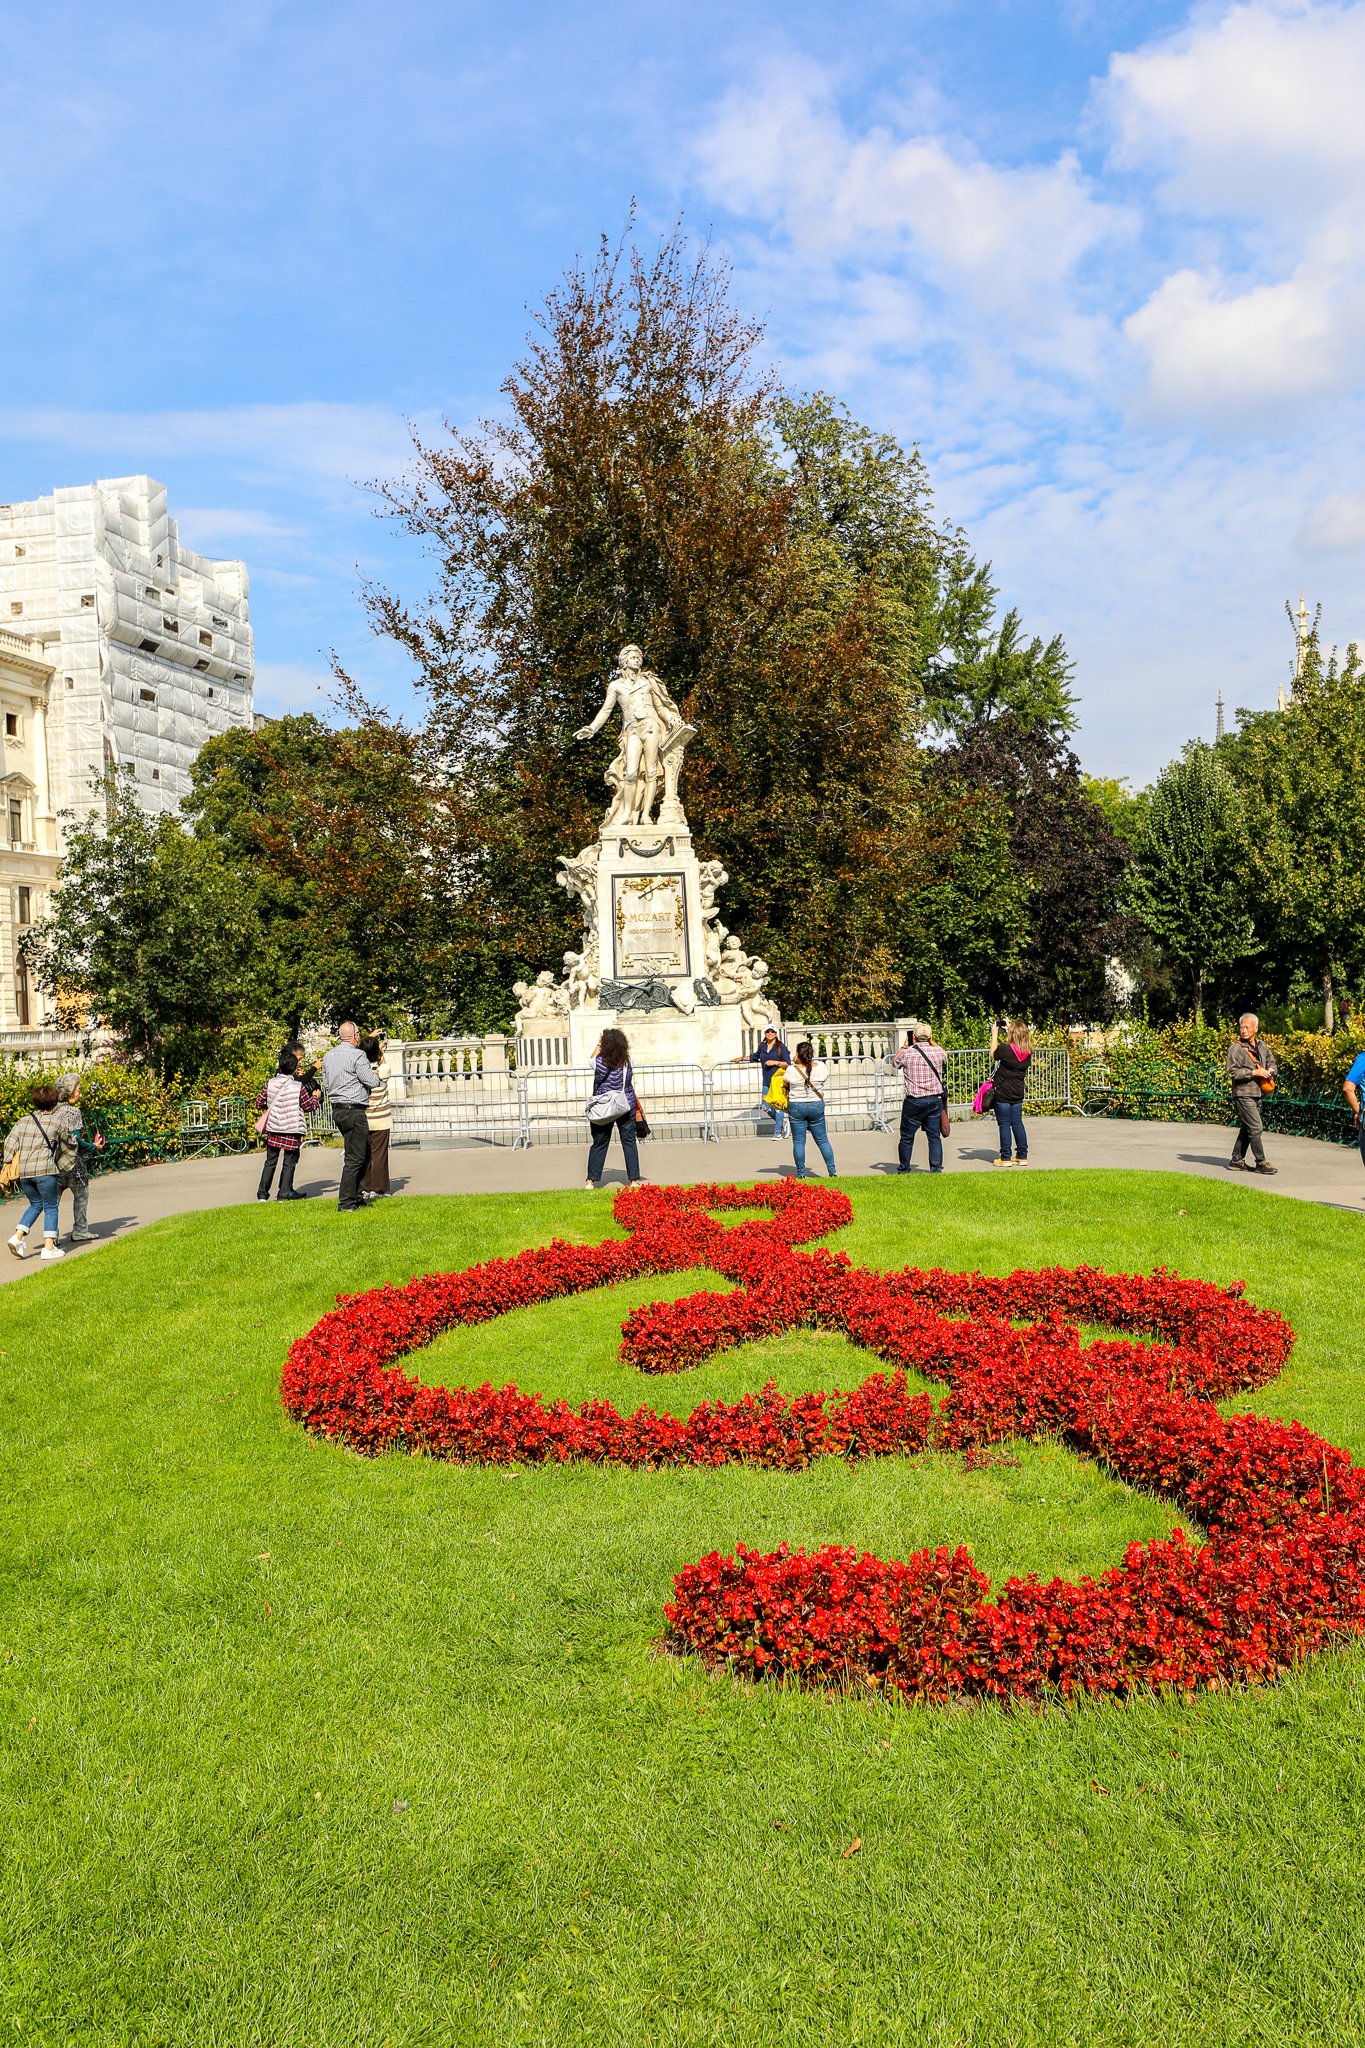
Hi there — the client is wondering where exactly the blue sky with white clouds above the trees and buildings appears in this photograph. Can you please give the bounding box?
[0,0,1365,780]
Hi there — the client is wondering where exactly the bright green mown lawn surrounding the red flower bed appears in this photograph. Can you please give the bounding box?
[0,1159,1365,2048]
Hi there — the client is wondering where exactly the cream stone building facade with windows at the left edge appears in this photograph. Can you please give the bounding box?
[0,627,61,1032]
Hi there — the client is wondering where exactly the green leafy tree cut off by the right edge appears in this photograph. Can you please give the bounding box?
[1224,635,1365,1030]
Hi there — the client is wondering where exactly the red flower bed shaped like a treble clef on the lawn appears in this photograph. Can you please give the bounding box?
[282,1182,1365,1700]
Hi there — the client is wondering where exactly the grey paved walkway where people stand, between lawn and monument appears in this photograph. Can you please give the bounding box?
[0,1116,1365,1280]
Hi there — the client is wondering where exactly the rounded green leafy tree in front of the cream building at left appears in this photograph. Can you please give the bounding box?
[25,784,260,1075]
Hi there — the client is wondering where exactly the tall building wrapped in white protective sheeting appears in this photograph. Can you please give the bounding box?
[0,477,254,815]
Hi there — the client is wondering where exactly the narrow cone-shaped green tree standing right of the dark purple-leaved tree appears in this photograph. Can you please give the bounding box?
[1130,741,1257,1024]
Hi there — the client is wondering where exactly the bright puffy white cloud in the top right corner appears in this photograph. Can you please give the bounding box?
[1099,0,1365,422]
